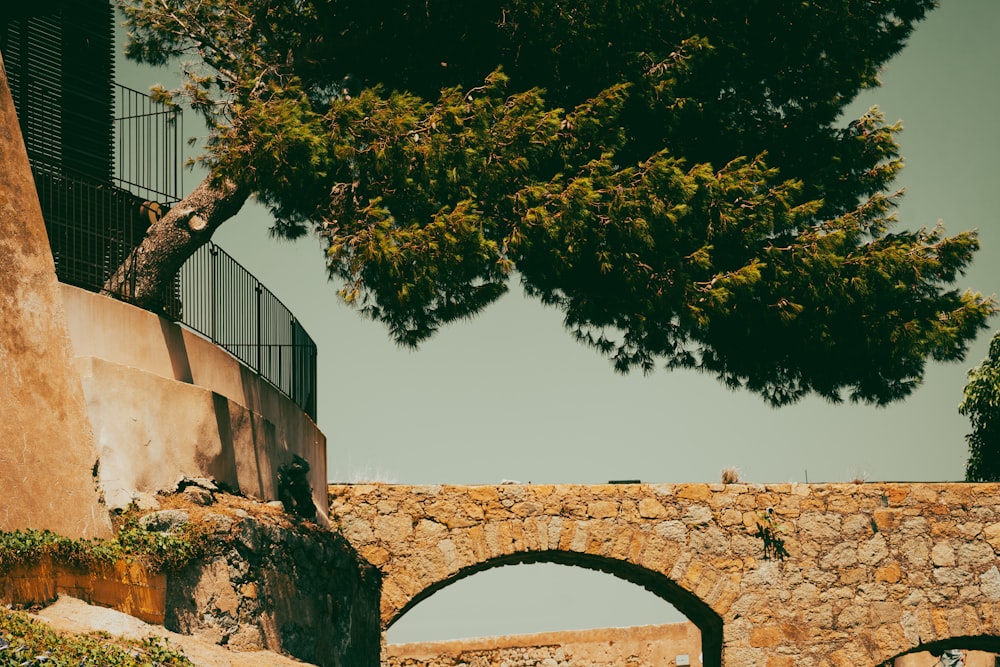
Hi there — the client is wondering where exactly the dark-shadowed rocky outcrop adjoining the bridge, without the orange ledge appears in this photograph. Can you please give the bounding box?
[153,494,379,667]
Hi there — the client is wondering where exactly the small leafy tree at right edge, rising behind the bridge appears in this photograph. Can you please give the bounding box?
[958,332,1000,482]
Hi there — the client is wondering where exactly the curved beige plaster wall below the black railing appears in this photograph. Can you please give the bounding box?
[62,285,326,517]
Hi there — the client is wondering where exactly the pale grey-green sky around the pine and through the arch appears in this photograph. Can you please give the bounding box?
[119,0,1000,642]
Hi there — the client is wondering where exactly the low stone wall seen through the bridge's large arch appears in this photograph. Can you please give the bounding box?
[382,623,701,667]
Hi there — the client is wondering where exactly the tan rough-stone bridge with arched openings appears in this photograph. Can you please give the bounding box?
[329,484,1000,667]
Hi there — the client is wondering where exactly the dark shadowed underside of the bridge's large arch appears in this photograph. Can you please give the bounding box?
[385,550,722,667]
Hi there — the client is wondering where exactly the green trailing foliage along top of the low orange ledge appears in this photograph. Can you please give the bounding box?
[0,510,210,572]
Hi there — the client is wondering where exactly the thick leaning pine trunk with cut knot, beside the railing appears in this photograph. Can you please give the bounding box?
[101,175,250,311]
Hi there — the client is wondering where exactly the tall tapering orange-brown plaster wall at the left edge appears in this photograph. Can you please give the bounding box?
[0,54,111,537]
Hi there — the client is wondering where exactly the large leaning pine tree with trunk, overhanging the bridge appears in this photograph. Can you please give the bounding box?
[109,0,995,405]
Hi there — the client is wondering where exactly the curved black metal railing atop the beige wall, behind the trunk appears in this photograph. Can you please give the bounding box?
[33,165,316,419]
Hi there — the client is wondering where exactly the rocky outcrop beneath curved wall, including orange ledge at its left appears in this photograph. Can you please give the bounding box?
[0,490,381,667]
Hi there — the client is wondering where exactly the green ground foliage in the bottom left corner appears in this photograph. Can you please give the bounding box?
[0,610,194,667]
